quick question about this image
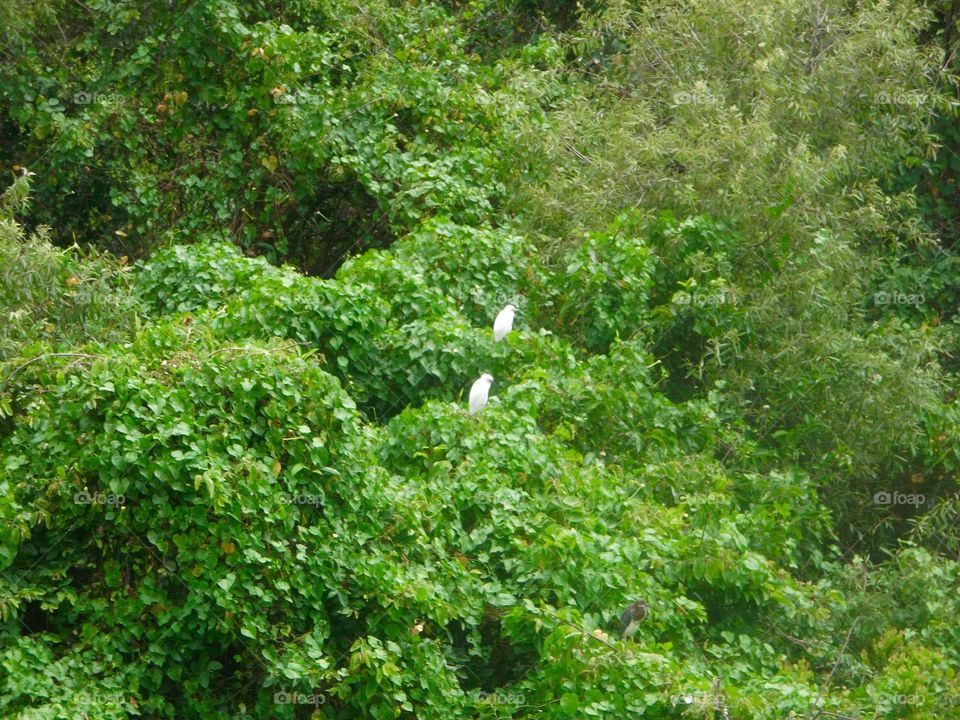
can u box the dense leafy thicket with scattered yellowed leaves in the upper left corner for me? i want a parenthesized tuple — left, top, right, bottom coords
(0, 0, 524, 268)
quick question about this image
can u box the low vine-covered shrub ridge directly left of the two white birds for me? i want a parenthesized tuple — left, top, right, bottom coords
(137, 229, 543, 422)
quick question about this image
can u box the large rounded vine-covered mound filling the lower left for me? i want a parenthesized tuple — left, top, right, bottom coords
(0, 324, 476, 716)
